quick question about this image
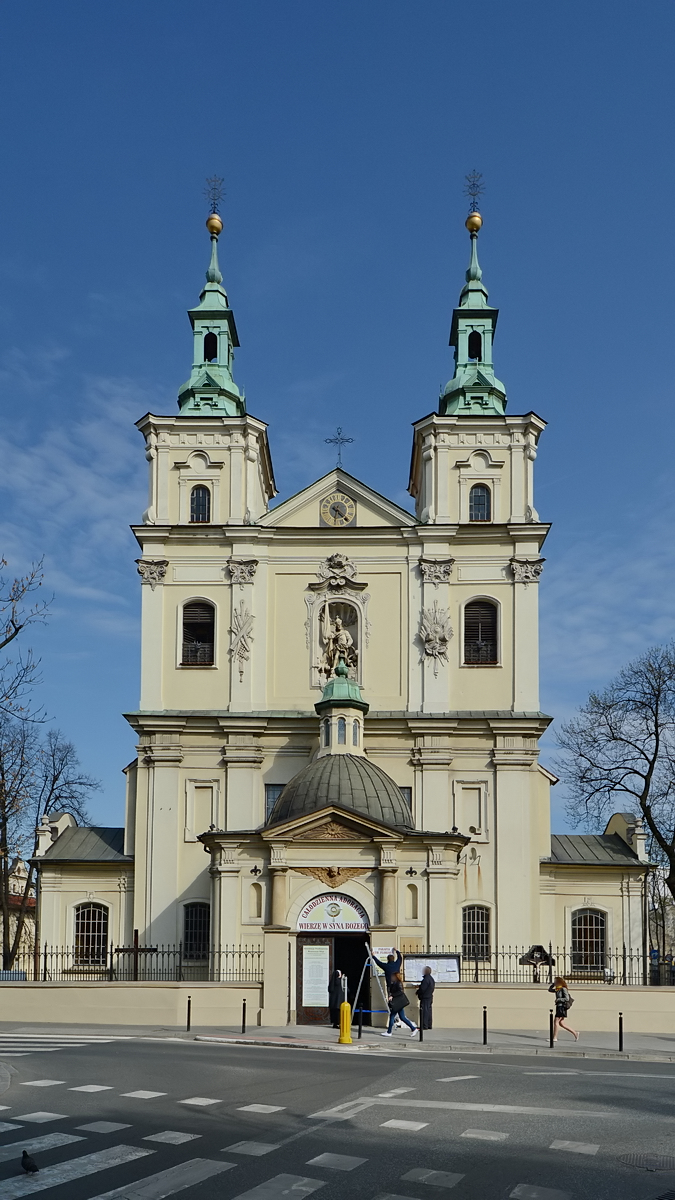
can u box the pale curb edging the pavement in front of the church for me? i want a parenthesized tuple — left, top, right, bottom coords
(193, 1034, 675, 1063)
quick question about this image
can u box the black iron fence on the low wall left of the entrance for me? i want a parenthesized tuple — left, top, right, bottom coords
(4, 943, 264, 983)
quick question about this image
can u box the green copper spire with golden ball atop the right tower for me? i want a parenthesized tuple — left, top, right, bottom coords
(438, 211, 507, 416)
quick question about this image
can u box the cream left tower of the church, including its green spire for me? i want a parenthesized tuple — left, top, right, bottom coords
(125, 212, 276, 944)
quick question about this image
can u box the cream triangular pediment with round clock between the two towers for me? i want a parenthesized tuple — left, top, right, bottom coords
(257, 467, 417, 533)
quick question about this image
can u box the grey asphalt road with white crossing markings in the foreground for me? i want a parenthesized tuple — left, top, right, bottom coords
(0, 1031, 675, 1200)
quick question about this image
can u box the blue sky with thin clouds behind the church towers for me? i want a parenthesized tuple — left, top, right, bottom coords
(0, 0, 675, 830)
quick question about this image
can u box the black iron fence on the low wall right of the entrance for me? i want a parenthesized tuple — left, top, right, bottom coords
(401, 942, 653, 986)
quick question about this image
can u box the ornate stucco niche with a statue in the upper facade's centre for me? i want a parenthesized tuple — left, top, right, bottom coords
(305, 553, 370, 686)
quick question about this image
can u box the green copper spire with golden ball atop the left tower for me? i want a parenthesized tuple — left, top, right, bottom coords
(178, 212, 246, 416)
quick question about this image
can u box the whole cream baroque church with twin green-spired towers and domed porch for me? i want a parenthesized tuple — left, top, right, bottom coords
(36, 204, 647, 1025)
